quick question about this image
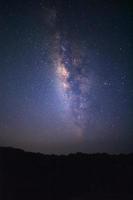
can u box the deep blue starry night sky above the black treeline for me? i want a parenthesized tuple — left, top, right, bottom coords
(0, 0, 133, 154)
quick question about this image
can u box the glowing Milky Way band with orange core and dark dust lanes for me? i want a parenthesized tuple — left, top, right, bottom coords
(54, 31, 91, 133)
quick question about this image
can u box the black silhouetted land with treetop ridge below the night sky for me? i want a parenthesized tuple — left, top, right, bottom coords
(0, 147, 133, 200)
